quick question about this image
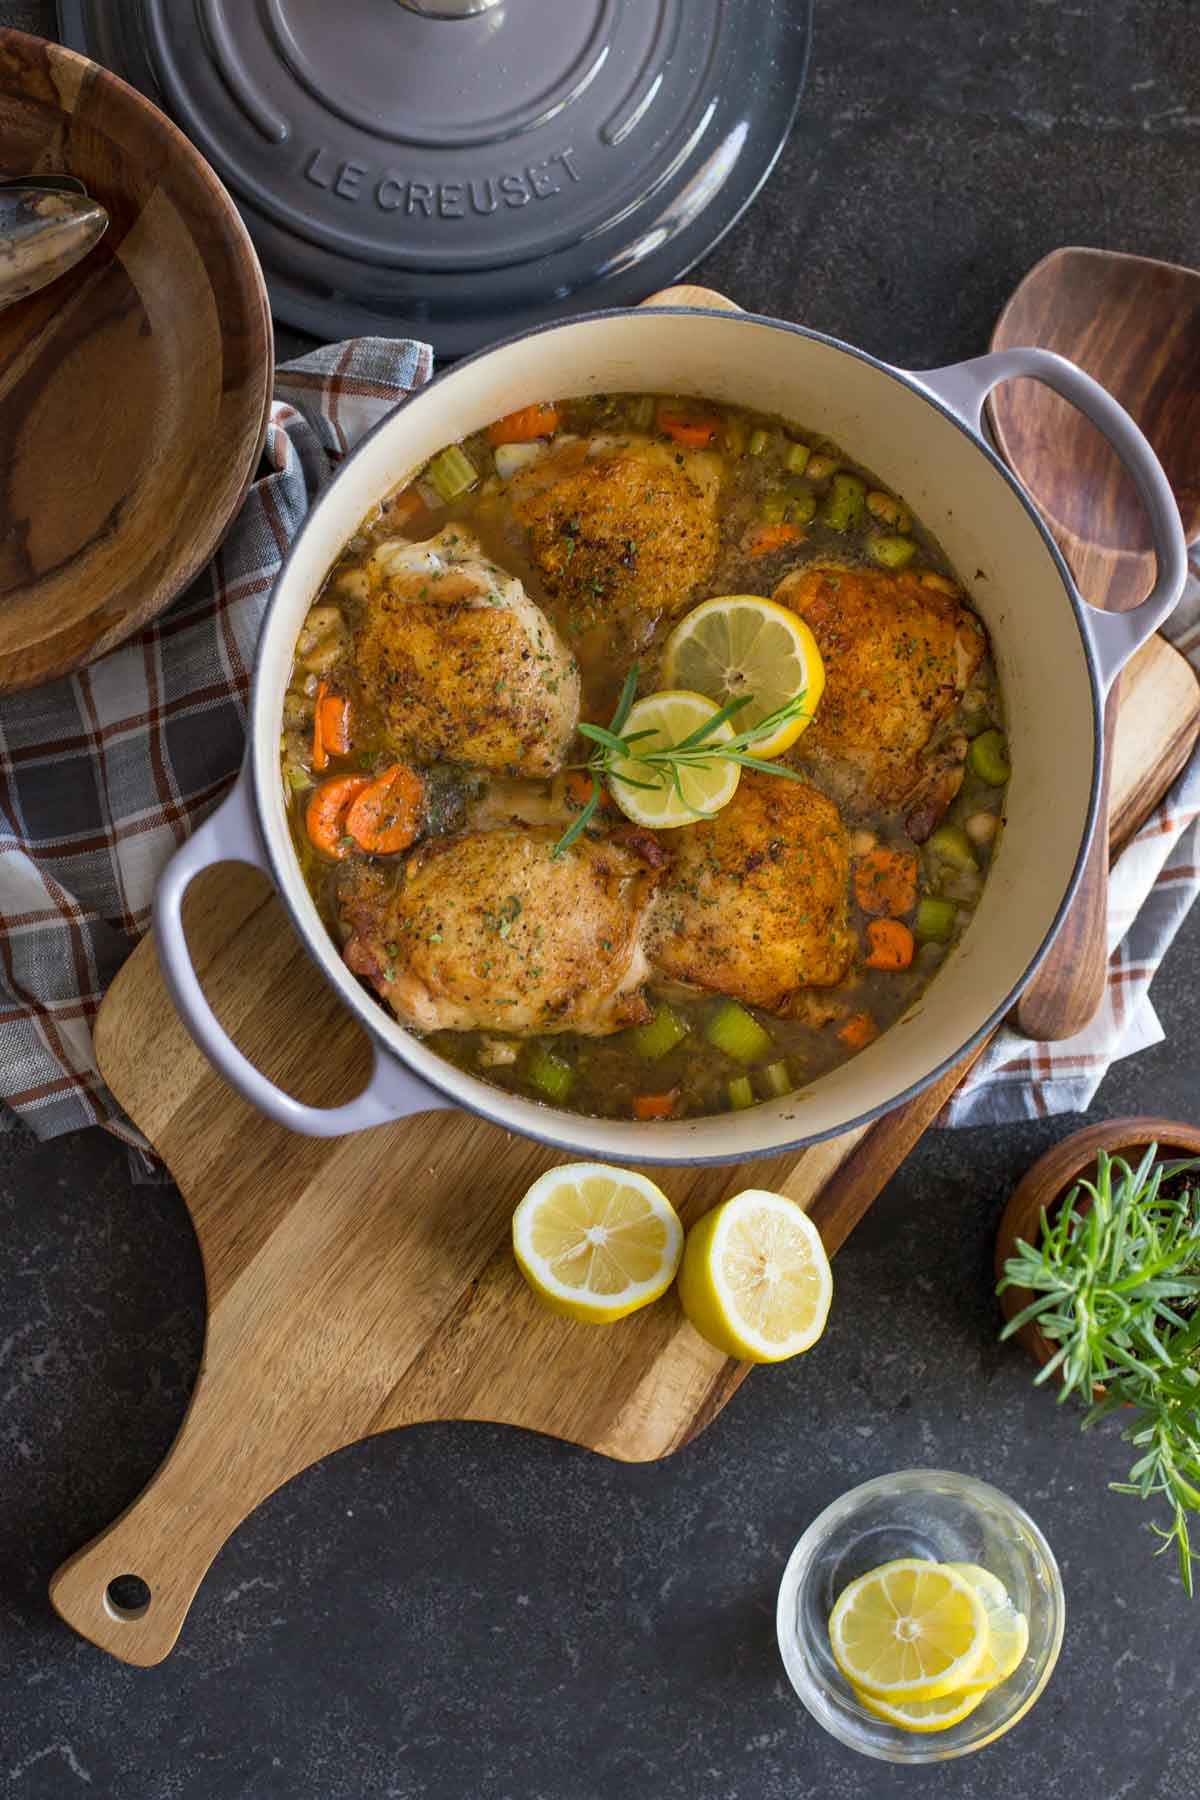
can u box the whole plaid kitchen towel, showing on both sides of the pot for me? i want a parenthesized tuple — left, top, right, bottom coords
(0, 338, 1200, 1145)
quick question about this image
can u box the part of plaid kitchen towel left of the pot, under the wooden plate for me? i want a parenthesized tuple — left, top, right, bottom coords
(0, 338, 432, 1143)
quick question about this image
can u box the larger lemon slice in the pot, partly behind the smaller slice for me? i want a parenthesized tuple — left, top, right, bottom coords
(662, 594, 826, 756)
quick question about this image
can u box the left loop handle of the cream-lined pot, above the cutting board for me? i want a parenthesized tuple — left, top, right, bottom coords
(155, 767, 453, 1138)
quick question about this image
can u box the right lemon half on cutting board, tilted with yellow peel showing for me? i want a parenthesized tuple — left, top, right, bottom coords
(678, 1188, 833, 1363)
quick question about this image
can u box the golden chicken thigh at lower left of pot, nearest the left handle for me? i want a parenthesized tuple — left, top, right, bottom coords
(340, 826, 658, 1037)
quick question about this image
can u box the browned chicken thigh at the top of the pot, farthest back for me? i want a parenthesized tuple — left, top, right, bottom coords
(509, 436, 720, 634)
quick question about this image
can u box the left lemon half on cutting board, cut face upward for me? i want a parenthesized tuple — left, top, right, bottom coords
(513, 1163, 684, 1325)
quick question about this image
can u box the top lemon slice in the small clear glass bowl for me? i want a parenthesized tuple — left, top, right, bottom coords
(829, 1557, 988, 1705)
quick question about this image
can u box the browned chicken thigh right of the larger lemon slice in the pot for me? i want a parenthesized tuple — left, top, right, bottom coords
(774, 563, 986, 835)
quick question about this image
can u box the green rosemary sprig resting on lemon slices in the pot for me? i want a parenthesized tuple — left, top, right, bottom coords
(552, 662, 806, 857)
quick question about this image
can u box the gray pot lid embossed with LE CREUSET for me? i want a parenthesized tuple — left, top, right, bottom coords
(59, 0, 811, 356)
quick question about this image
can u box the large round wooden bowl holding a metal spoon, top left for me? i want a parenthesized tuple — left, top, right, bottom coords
(0, 31, 272, 691)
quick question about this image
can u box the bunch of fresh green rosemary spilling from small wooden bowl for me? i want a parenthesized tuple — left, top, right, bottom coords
(999, 1145, 1200, 1595)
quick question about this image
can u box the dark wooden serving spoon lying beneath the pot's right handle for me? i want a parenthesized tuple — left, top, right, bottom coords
(988, 248, 1200, 1040)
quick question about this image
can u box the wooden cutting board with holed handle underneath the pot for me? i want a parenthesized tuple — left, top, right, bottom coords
(50, 639, 1200, 1665)
